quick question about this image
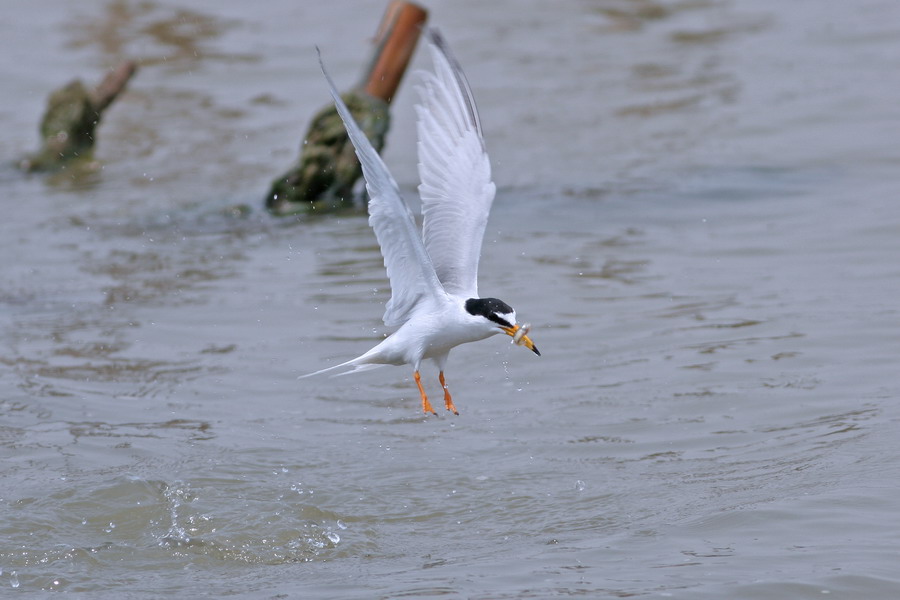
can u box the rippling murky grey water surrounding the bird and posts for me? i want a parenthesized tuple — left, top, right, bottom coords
(0, 0, 900, 599)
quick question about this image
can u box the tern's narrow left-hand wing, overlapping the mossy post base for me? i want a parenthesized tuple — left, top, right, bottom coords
(319, 50, 445, 327)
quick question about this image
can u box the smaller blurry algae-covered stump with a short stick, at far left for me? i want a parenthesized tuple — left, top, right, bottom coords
(19, 61, 137, 171)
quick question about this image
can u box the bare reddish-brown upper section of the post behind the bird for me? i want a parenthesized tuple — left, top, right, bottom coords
(361, 0, 428, 102)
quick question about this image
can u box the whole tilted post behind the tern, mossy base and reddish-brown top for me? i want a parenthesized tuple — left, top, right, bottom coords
(266, 0, 427, 214)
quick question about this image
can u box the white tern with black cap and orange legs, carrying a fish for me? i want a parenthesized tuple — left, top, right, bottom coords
(302, 29, 541, 415)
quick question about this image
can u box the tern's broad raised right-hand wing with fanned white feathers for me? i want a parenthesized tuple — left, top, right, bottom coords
(416, 29, 496, 298)
